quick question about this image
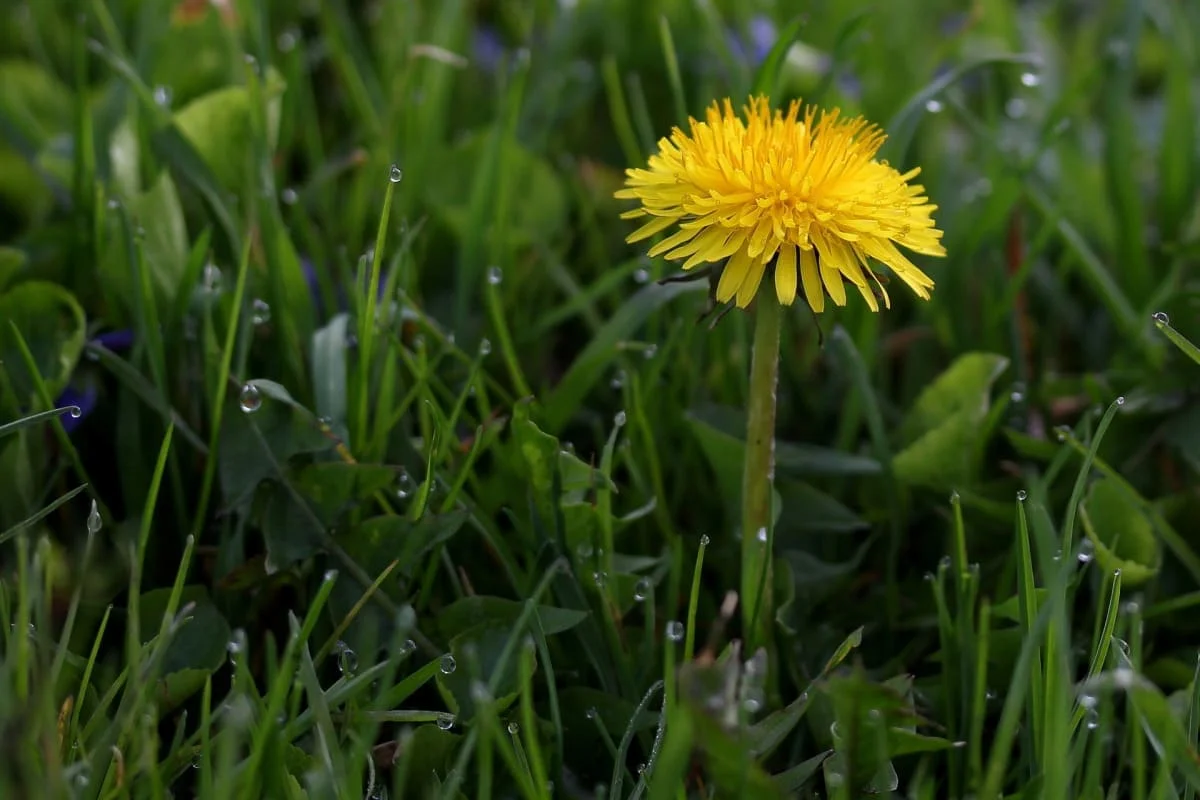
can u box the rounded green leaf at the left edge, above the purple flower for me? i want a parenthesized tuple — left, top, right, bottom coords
(0, 281, 86, 404)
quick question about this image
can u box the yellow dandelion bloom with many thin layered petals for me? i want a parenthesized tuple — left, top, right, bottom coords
(616, 97, 946, 312)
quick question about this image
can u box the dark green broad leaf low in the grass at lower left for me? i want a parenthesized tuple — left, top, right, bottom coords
(138, 585, 229, 717)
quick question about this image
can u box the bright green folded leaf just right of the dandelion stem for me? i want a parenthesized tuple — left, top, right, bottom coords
(893, 353, 1008, 489)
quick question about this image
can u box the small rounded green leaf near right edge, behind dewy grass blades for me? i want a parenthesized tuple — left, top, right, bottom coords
(1079, 477, 1163, 587)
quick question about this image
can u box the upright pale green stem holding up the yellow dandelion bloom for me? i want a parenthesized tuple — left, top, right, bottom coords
(742, 287, 782, 654)
